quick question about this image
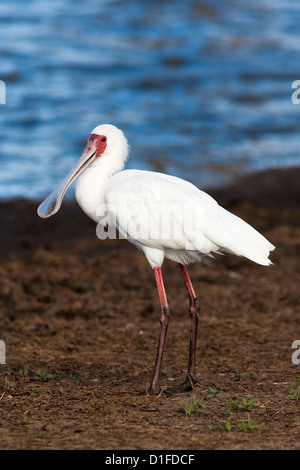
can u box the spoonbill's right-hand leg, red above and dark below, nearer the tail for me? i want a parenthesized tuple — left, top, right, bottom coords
(180, 264, 200, 385)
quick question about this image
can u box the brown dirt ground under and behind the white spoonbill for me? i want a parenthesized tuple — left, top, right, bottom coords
(0, 169, 300, 450)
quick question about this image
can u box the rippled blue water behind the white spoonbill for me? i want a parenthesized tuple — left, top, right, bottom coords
(0, 0, 300, 198)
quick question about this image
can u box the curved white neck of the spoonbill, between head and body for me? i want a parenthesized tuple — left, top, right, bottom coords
(75, 147, 128, 222)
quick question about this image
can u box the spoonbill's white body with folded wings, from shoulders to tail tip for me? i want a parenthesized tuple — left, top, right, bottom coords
(104, 170, 274, 265)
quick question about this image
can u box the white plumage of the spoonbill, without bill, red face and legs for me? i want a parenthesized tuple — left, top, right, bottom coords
(72, 125, 274, 268)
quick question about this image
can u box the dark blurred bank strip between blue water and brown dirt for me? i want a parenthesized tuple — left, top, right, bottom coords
(0, 167, 300, 258)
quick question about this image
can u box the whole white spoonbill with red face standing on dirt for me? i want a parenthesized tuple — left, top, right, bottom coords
(38, 124, 275, 394)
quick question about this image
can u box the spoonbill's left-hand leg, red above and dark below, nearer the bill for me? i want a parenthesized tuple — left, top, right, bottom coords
(148, 267, 170, 395)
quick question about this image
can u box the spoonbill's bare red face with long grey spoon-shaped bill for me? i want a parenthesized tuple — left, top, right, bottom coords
(38, 134, 107, 219)
